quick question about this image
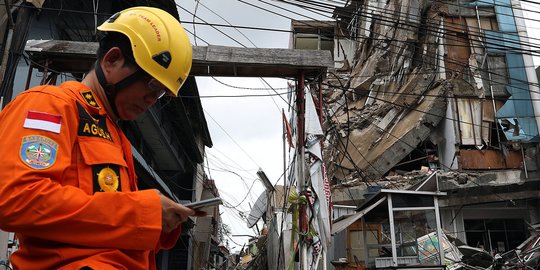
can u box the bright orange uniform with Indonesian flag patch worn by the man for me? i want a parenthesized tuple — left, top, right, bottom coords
(0, 82, 180, 270)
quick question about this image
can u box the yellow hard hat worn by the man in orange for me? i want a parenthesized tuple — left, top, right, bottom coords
(97, 7, 192, 96)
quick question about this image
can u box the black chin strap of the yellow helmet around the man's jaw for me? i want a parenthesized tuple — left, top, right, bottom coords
(94, 60, 146, 119)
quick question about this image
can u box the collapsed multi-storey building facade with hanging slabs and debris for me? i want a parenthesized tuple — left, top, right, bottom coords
(292, 0, 540, 265)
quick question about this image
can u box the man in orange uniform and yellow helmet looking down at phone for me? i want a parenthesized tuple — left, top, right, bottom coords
(0, 7, 201, 270)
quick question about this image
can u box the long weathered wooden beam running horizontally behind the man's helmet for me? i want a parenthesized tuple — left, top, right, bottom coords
(25, 40, 334, 78)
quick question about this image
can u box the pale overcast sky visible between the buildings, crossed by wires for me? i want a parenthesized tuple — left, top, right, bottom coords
(177, 0, 540, 251)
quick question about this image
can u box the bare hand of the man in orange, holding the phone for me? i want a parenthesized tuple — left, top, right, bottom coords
(156, 190, 198, 232)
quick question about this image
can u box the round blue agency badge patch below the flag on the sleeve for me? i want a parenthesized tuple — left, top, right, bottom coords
(19, 135, 58, 170)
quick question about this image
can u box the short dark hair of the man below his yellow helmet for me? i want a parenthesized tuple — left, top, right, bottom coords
(96, 32, 137, 66)
